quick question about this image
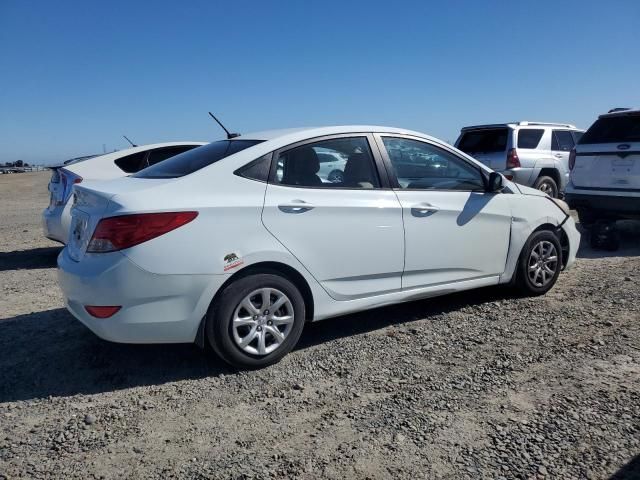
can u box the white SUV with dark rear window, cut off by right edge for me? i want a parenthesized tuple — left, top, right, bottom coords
(566, 109, 640, 226)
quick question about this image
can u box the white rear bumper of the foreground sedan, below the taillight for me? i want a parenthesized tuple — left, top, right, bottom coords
(58, 248, 228, 343)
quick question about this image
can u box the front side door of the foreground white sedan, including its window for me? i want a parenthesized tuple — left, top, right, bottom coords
(376, 135, 511, 289)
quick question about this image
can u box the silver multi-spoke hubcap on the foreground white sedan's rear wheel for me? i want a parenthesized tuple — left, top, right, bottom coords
(231, 288, 294, 356)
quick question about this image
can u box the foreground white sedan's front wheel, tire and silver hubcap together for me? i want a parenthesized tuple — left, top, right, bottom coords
(516, 230, 562, 296)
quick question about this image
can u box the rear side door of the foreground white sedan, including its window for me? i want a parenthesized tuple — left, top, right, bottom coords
(262, 134, 404, 300)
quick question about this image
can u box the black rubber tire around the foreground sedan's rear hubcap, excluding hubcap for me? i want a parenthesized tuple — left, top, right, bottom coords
(206, 273, 305, 369)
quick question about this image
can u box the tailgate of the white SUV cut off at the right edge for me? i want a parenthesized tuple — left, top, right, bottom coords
(571, 112, 640, 193)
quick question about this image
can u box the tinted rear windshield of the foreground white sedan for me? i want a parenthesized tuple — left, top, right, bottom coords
(133, 140, 262, 178)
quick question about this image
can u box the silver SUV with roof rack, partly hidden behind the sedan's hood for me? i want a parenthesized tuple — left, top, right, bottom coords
(456, 122, 583, 198)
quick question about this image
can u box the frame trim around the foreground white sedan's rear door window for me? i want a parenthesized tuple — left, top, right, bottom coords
(268, 132, 392, 192)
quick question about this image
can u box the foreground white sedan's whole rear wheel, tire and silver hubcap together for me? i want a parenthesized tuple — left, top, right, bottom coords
(205, 273, 305, 369)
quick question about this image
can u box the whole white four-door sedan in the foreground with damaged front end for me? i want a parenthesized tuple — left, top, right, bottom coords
(58, 126, 580, 368)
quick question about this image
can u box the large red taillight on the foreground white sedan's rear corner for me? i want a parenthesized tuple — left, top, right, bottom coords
(87, 212, 198, 253)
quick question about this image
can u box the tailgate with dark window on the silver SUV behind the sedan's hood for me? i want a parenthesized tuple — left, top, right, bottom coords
(456, 126, 511, 172)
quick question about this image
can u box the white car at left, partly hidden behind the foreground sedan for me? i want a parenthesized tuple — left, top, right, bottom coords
(42, 142, 206, 243)
